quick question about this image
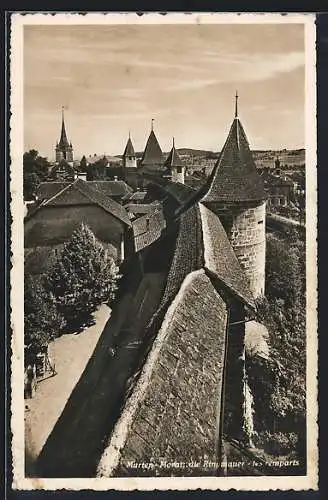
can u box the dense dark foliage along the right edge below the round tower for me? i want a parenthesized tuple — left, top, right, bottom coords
(247, 231, 306, 448)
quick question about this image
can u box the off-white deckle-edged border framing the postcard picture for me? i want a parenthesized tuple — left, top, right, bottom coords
(10, 12, 318, 491)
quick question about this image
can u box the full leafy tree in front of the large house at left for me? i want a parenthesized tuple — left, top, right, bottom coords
(47, 224, 119, 328)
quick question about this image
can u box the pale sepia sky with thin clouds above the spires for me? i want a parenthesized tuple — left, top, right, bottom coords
(24, 24, 305, 160)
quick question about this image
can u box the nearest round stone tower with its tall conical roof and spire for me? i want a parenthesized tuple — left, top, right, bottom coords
(202, 93, 266, 297)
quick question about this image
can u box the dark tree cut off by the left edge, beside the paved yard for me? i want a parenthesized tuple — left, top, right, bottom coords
(24, 275, 64, 352)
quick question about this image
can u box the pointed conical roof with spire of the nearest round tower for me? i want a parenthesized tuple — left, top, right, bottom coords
(202, 93, 266, 202)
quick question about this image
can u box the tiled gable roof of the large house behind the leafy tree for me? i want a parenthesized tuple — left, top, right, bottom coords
(39, 179, 131, 226)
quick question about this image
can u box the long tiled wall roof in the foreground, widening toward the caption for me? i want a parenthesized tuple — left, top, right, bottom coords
(108, 271, 227, 476)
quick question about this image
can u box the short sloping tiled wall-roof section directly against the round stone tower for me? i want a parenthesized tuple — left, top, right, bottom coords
(199, 203, 254, 307)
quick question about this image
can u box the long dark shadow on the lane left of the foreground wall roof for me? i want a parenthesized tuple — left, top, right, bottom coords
(33, 229, 174, 477)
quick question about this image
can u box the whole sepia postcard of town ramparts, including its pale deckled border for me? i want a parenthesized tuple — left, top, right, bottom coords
(10, 13, 317, 490)
